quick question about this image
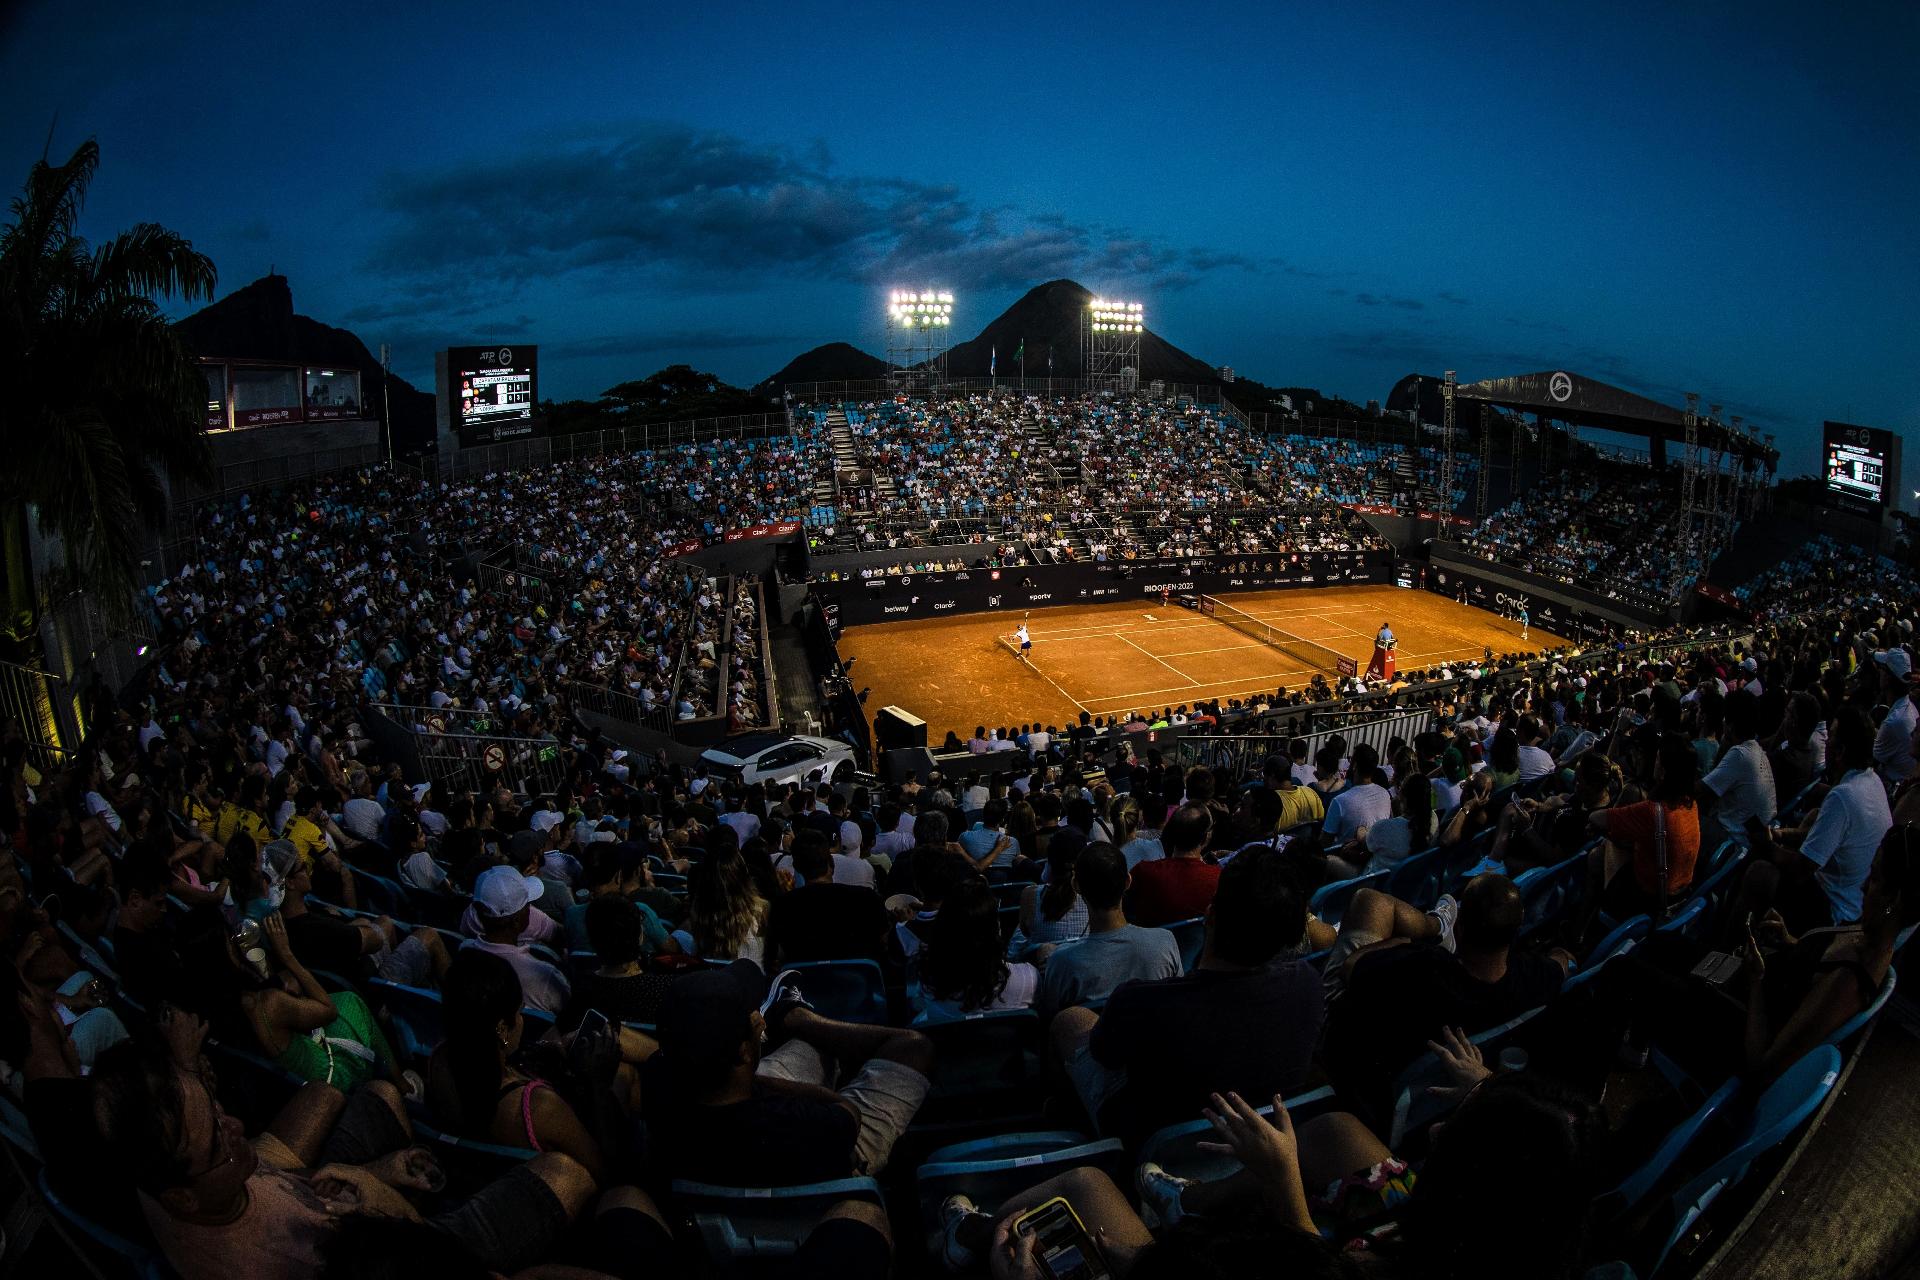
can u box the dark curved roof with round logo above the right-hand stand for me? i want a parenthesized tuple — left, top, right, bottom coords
(1386, 368, 1780, 462)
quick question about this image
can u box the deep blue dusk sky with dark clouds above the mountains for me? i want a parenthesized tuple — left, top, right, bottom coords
(0, 2, 1920, 482)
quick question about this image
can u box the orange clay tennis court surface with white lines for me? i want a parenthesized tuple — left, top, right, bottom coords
(839, 585, 1563, 745)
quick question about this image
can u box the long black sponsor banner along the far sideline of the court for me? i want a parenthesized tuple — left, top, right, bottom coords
(814, 551, 1394, 626)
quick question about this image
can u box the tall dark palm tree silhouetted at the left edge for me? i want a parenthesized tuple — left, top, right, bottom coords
(0, 140, 215, 631)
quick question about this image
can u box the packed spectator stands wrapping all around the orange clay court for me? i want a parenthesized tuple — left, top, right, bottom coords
(0, 383, 1920, 1280)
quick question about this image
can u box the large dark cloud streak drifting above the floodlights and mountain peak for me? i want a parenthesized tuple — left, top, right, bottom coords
(367, 123, 1265, 317)
